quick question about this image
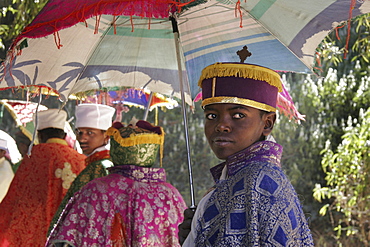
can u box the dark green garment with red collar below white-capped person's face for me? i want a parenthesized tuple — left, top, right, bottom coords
(48, 150, 113, 233)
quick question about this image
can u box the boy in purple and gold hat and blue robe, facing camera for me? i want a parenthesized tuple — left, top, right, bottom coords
(179, 63, 313, 247)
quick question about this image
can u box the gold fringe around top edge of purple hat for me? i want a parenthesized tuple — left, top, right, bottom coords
(198, 63, 283, 92)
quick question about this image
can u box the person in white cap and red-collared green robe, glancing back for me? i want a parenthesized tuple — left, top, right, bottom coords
(49, 104, 115, 233)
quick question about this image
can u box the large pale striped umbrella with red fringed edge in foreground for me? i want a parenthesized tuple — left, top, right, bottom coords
(0, 0, 370, 206)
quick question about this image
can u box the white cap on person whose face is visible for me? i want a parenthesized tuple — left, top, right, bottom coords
(75, 104, 116, 130)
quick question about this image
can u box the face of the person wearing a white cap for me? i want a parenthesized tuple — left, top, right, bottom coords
(76, 128, 109, 155)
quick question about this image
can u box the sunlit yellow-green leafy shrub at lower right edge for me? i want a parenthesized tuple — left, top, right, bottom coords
(314, 108, 370, 246)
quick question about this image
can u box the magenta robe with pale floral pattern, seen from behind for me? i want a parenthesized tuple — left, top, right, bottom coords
(47, 165, 186, 247)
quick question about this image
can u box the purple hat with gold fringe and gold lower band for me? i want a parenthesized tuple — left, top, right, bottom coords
(198, 63, 283, 112)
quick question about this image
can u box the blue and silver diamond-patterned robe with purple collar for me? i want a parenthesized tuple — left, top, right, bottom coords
(195, 141, 313, 247)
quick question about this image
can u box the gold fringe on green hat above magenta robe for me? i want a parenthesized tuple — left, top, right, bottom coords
(106, 127, 165, 167)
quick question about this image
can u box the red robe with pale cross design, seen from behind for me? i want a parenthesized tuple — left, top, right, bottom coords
(0, 138, 85, 247)
